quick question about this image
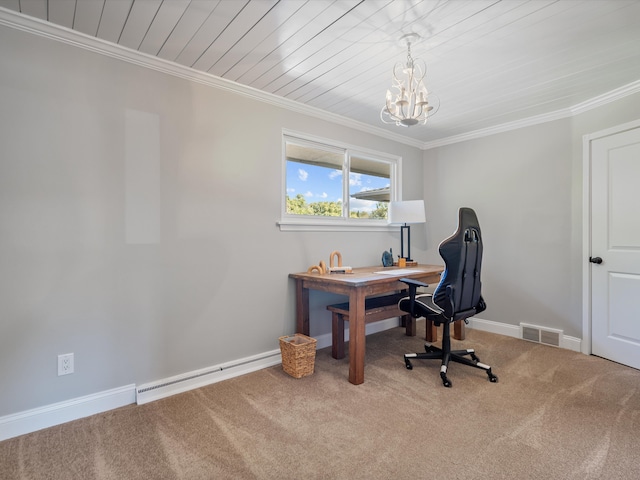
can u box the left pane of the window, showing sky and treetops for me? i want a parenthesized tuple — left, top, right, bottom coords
(286, 142, 344, 217)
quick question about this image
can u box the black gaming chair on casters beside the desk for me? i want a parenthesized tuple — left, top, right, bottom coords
(398, 208, 498, 387)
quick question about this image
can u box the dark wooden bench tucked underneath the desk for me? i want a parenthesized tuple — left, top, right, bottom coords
(327, 292, 465, 359)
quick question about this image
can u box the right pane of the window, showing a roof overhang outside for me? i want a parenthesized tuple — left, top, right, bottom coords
(349, 156, 391, 220)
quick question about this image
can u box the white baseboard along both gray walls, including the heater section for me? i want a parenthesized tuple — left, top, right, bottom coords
(0, 318, 581, 441)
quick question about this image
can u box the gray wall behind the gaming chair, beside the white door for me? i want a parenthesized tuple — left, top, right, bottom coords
(424, 94, 640, 338)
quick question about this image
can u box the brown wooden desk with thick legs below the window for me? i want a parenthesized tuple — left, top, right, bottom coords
(289, 265, 444, 385)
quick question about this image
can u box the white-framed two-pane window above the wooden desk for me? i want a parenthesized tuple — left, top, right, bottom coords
(280, 133, 400, 229)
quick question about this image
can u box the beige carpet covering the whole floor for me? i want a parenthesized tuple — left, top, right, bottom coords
(0, 323, 640, 480)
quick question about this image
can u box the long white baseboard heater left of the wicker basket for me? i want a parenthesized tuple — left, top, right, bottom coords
(136, 349, 282, 405)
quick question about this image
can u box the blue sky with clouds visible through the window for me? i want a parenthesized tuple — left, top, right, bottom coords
(287, 161, 389, 210)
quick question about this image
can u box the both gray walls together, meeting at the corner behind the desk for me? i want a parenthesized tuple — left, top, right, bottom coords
(0, 19, 640, 416)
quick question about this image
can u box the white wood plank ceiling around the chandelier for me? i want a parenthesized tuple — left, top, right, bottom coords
(0, 0, 640, 144)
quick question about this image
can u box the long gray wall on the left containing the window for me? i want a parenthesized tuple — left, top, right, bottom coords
(0, 26, 424, 416)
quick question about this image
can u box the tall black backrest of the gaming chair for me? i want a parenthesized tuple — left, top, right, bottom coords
(433, 207, 486, 318)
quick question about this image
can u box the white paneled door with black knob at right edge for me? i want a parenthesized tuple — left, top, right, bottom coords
(590, 128, 640, 368)
